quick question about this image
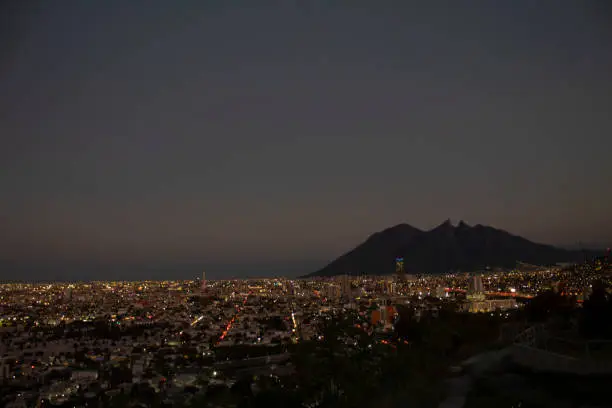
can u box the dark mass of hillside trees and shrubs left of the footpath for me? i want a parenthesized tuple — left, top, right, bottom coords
(208, 313, 502, 407)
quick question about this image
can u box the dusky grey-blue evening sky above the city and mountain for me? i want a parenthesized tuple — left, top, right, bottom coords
(0, 0, 612, 279)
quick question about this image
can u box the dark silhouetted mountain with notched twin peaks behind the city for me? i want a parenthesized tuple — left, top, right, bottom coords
(308, 220, 592, 276)
